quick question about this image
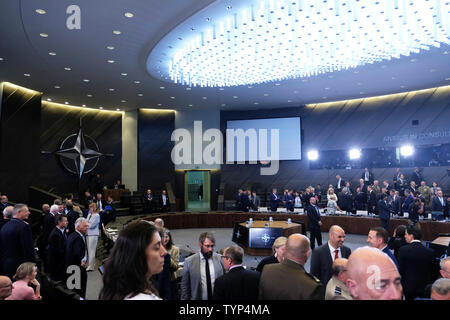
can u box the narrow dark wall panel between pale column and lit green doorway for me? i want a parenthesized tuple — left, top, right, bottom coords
(138, 109, 175, 192)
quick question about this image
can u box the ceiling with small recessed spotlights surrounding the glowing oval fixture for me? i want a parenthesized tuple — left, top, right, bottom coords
(0, 0, 450, 110)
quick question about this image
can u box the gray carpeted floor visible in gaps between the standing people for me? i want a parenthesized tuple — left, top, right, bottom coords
(86, 220, 367, 300)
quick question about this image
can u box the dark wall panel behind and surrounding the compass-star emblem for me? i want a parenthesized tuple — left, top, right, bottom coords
(37, 102, 122, 195)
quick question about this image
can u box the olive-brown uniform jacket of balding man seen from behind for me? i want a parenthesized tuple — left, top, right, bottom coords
(259, 259, 324, 300)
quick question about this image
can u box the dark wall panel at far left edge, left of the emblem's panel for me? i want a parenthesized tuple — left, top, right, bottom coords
(0, 84, 42, 203)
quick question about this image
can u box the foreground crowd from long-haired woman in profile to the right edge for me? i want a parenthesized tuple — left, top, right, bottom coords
(92, 215, 450, 300)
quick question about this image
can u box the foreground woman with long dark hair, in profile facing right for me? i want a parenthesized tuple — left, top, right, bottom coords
(99, 221, 167, 300)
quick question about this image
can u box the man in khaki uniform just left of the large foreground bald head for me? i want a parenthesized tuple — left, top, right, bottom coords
(325, 258, 353, 300)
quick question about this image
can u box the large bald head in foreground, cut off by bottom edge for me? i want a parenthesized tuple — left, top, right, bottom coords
(346, 247, 403, 300)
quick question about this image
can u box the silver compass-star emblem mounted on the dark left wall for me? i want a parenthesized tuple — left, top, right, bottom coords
(42, 119, 114, 179)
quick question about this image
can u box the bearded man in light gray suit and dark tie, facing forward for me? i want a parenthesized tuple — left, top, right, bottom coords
(181, 232, 224, 300)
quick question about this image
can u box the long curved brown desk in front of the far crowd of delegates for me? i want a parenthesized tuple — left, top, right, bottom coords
(143, 212, 450, 241)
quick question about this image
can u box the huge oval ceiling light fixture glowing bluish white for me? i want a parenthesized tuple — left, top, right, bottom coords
(147, 0, 450, 87)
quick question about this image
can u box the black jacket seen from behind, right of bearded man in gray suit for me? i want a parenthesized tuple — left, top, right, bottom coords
(213, 267, 260, 300)
